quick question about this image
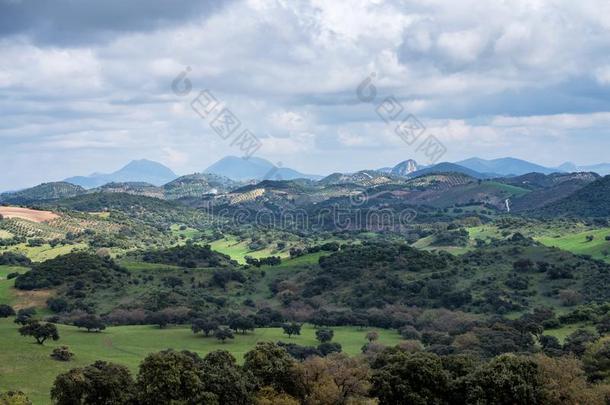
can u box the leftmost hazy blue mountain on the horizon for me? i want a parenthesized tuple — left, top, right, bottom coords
(64, 159, 178, 189)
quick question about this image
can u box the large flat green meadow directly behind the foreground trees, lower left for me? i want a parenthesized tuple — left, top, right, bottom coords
(0, 318, 400, 405)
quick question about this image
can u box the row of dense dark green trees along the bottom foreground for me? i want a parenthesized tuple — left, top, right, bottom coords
(0, 342, 592, 405)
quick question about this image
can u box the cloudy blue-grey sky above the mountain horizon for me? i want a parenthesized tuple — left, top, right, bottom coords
(0, 0, 610, 190)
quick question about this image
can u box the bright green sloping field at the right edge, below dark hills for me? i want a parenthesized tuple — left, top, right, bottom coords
(536, 228, 610, 263)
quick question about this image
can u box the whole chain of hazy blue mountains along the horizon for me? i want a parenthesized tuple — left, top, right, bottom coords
(5, 156, 610, 194)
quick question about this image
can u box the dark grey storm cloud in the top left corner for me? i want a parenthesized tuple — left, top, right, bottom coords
(0, 0, 231, 45)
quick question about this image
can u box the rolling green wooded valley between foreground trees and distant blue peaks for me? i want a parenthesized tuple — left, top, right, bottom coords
(0, 159, 610, 404)
